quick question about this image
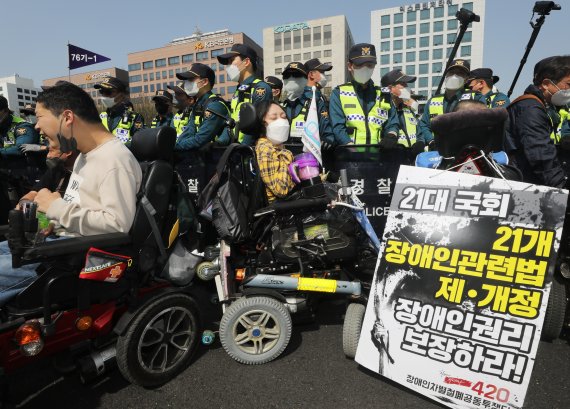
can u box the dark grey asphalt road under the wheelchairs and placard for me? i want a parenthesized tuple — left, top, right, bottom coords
(4, 296, 570, 409)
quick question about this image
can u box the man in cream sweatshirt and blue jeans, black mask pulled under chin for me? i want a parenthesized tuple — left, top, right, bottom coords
(0, 83, 142, 305)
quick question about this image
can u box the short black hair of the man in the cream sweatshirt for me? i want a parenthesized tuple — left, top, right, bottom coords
(36, 82, 101, 123)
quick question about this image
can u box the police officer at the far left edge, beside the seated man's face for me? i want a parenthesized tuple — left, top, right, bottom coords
(0, 95, 40, 161)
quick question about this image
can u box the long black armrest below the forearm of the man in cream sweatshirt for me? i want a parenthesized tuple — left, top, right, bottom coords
(24, 233, 131, 260)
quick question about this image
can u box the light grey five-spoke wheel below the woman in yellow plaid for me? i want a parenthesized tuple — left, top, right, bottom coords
(220, 297, 292, 365)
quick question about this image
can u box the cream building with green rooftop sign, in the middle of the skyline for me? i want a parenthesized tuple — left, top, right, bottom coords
(263, 16, 354, 93)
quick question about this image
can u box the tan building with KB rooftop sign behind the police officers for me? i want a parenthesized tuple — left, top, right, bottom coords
(128, 30, 263, 99)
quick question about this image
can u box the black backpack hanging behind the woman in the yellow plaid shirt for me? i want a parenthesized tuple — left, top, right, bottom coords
(198, 143, 266, 244)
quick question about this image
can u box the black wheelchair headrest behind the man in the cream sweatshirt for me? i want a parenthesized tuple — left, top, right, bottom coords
(131, 126, 176, 162)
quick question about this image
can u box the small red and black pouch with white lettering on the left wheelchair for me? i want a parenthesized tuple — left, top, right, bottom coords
(79, 247, 132, 283)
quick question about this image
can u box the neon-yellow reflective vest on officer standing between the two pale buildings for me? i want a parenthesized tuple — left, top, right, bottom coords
(339, 84, 391, 145)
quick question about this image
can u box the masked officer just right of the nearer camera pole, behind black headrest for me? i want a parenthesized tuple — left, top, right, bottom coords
(417, 59, 472, 145)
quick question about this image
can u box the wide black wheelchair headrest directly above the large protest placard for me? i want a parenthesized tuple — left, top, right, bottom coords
(431, 108, 508, 157)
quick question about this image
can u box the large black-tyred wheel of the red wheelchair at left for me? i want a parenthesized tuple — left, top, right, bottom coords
(117, 293, 199, 387)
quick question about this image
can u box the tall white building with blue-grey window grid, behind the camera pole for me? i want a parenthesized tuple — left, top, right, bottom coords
(371, 0, 485, 97)
